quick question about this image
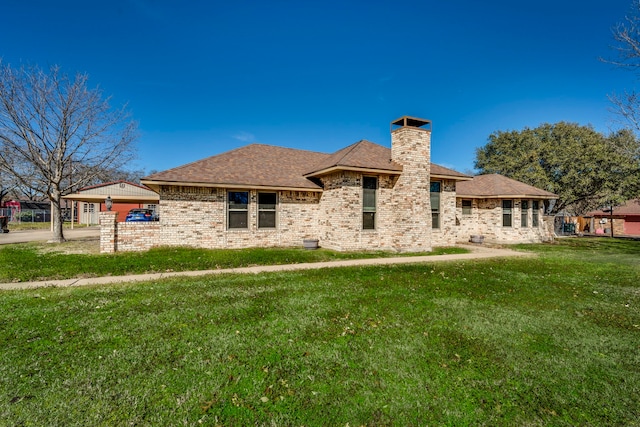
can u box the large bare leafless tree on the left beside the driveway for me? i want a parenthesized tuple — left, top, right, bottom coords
(0, 62, 137, 242)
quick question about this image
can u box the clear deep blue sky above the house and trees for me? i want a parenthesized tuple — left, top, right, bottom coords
(0, 0, 636, 176)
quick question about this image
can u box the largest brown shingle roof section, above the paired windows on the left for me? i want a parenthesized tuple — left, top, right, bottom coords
(142, 144, 328, 191)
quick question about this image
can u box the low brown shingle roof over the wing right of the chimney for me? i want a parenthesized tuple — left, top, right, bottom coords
(456, 174, 558, 199)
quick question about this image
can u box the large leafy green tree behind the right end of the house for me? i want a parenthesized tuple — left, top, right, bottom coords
(475, 122, 640, 214)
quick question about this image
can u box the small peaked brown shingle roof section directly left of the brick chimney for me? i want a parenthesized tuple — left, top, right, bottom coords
(305, 140, 402, 177)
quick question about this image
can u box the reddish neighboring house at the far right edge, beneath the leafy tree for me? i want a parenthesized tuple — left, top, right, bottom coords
(585, 199, 640, 236)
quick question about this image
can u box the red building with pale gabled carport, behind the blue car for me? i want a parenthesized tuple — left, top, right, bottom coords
(62, 181, 159, 224)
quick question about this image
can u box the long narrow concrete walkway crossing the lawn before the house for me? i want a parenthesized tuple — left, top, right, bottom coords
(0, 245, 535, 291)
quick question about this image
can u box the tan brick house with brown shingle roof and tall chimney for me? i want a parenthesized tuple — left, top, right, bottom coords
(102, 117, 555, 252)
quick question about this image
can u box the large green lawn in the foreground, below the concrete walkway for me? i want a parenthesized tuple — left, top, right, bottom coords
(0, 239, 640, 426)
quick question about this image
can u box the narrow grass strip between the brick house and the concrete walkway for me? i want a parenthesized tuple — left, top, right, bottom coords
(0, 241, 468, 283)
